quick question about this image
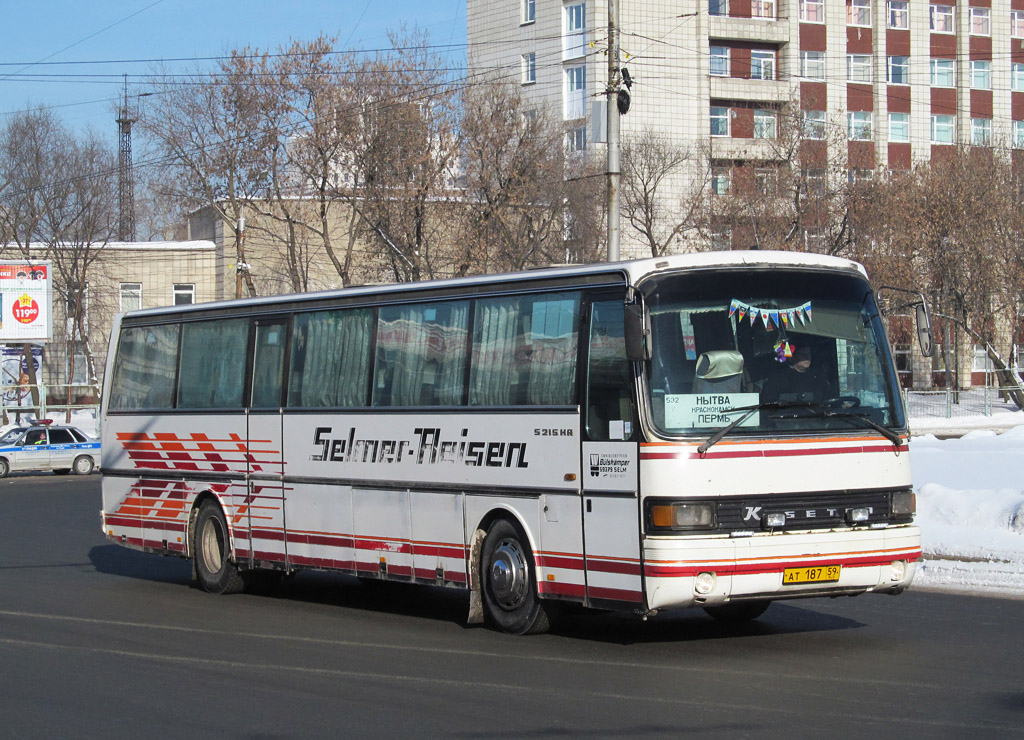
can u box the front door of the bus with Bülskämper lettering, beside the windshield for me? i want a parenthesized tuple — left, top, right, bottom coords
(582, 298, 643, 609)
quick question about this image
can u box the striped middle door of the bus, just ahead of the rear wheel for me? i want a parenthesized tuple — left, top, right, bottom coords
(247, 318, 288, 565)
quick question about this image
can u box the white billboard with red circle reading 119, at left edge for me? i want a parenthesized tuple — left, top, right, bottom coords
(0, 261, 53, 344)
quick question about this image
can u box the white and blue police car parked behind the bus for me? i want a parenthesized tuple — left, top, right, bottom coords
(0, 424, 99, 478)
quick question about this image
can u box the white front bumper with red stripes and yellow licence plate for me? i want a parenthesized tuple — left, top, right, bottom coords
(643, 525, 921, 610)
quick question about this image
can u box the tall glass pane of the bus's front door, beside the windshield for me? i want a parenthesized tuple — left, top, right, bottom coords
(587, 300, 637, 441)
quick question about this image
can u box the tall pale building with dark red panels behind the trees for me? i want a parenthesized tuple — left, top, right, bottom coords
(467, 0, 1024, 256)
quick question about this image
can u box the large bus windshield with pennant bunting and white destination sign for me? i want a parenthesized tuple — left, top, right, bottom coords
(641, 267, 904, 437)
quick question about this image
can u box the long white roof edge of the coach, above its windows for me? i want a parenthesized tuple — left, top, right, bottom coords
(125, 250, 867, 318)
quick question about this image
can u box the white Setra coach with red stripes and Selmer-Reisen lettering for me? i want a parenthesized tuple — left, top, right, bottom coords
(102, 252, 921, 634)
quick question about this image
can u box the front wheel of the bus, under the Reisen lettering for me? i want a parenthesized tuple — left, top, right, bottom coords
(480, 519, 552, 635)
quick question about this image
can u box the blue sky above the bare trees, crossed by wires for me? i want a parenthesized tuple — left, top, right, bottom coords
(0, 0, 466, 139)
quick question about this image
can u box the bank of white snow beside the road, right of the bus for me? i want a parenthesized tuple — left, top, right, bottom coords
(910, 426, 1024, 597)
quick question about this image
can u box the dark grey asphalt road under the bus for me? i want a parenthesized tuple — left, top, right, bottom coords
(0, 475, 1024, 740)
